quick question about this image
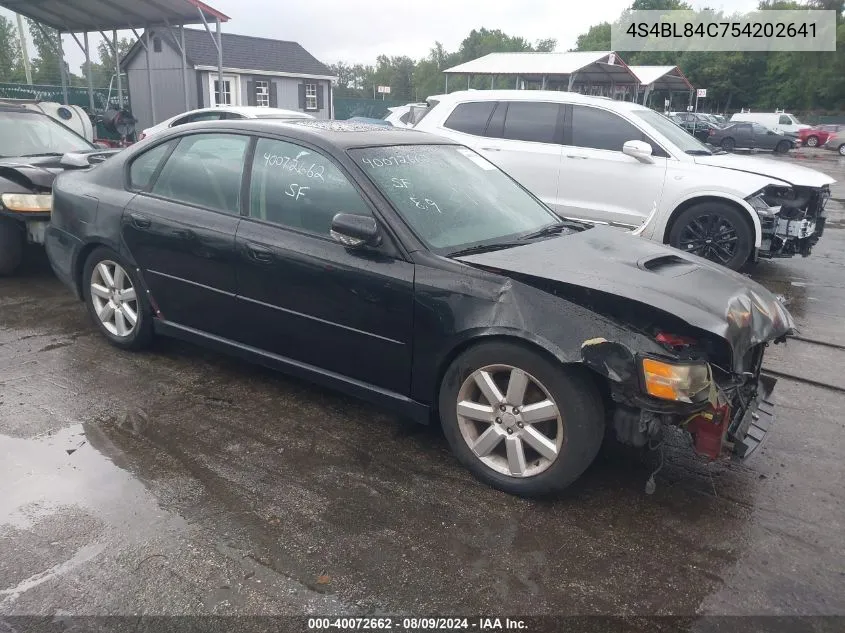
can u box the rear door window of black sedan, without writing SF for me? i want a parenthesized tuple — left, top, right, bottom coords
(153, 134, 249, 213)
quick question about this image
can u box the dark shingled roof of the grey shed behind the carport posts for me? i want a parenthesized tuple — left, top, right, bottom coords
(121, 29, 334, 77)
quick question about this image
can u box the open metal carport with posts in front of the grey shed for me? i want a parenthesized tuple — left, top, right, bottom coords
(0, 0, 229, 124)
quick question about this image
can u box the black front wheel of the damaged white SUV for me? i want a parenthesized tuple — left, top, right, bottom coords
(669, 202, 754, 270)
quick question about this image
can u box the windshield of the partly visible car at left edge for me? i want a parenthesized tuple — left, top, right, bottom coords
(0, 111, 95, 157)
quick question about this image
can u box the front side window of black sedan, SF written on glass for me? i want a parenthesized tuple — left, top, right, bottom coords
(249, 138, 372, 236)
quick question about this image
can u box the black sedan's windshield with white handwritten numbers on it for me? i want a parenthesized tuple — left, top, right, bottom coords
(350, 145, 560, 254)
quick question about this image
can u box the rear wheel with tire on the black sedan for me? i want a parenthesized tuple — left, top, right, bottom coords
(82, 247, 153, 350)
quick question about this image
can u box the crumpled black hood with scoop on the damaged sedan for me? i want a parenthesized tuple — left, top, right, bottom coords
(458, 226, 795, 369)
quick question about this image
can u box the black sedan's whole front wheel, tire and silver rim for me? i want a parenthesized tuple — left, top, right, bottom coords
(439, 341, 604, 497)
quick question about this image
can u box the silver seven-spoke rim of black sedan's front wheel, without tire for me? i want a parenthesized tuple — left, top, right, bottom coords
(457, 365, 564, 478)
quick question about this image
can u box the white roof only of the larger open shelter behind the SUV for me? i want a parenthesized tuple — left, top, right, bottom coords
(443, 51, 637, 84)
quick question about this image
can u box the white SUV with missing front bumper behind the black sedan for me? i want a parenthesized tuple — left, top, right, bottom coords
(415, 90, 835, 270)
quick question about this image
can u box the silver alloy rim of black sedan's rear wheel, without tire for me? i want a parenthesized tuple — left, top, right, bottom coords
(91, 260, 138, 337)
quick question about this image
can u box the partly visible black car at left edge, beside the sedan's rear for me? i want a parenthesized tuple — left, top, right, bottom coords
(0, 105, 113, 275)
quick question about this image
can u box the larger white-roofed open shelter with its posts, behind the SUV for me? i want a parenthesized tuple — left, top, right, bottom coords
(443, 51, 639, 95)
